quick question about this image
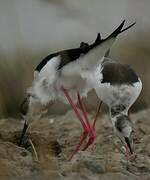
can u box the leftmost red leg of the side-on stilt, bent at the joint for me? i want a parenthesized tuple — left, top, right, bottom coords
(62, 87, 90, 159)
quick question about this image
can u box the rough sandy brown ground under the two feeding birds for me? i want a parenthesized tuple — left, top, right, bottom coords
(0, 109, 150, 180)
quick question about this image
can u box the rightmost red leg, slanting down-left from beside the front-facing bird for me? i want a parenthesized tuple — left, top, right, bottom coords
(82, 101, 102, 151)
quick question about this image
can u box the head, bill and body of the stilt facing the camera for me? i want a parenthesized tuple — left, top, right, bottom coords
(91, 50, 142, 156)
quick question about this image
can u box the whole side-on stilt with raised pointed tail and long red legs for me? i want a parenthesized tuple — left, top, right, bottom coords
(19, 20, 134, 158)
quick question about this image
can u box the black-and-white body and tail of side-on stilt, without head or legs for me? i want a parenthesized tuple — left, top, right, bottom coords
(24, 21, 134, 107)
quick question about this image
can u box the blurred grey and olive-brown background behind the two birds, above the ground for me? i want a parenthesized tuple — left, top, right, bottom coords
(0, 0, 150, 117)
